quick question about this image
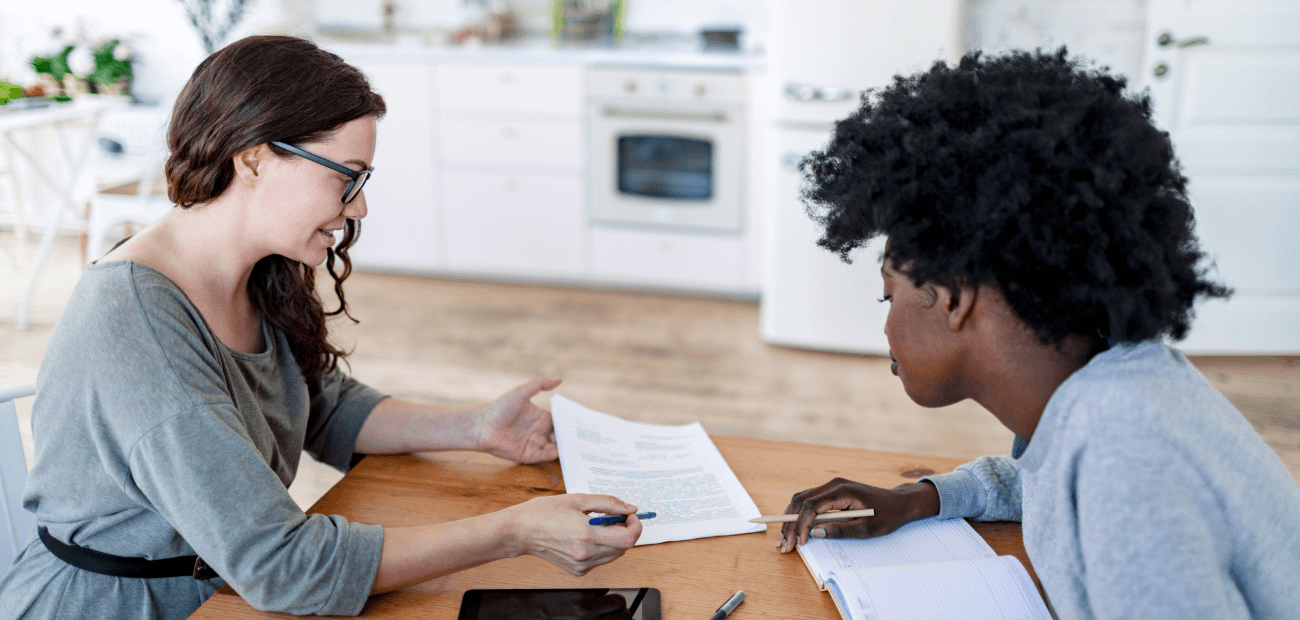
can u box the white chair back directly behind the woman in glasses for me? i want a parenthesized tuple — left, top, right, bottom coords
(0, 385, 36, 575)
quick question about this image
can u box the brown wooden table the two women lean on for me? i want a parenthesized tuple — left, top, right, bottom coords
(191, 437, 1041, 620)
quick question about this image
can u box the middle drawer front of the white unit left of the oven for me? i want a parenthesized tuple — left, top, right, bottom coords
(438, 117, 582, 170)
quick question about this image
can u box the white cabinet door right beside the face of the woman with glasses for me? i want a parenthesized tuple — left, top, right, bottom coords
(351, 61, 439, 270)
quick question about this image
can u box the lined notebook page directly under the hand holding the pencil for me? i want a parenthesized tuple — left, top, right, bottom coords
(796, 519, 997, 589)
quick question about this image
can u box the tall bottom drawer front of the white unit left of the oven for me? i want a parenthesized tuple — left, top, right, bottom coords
(442, 172, 586, 278)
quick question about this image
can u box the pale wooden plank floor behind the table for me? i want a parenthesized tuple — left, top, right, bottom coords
(0, 231, 1300, 506)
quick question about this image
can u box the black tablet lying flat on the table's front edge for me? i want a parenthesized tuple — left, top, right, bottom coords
(458, 588, 660, 620)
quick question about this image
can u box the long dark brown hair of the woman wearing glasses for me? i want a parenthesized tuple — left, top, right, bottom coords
(166, 36, 386, 382)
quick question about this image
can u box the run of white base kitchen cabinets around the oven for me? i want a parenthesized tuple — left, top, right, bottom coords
(334, 45, 758, 295)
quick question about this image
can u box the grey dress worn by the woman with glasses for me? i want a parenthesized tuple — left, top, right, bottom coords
(0, 261, 384, 620)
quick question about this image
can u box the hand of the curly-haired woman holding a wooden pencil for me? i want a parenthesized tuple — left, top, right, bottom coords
(776, 478, 939, 554)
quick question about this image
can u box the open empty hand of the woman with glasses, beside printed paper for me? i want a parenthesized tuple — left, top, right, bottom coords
(473, 377, 560, 463)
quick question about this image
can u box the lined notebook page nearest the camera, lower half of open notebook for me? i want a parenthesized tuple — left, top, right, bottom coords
(826, 555, 1052, 620)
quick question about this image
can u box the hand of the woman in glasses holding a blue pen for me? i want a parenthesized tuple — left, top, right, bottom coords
(502, 494, 641, 577)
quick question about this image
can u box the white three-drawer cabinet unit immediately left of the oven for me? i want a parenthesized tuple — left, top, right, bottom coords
(436, 62, 586, 278)
